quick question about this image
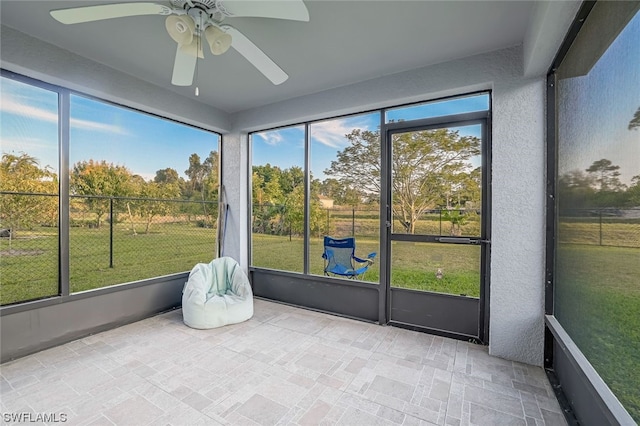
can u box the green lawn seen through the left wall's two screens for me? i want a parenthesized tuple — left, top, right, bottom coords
(0, 223, 215, 305)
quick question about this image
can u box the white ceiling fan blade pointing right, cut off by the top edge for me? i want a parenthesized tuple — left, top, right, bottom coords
(222, 0, 309, 22)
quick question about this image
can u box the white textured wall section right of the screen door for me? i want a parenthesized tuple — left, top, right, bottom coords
(489, 75, 545, 365)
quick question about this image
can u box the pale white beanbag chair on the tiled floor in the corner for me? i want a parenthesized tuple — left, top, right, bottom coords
(182, 257, 253, 329)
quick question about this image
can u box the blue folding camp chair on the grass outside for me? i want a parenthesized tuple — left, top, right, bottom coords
(322, 236, 376, 279)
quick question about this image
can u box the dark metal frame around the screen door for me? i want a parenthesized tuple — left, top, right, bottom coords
(379, 110, 491, 344)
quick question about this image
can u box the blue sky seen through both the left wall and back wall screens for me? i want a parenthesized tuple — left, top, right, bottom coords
(0, 73, 489, 183)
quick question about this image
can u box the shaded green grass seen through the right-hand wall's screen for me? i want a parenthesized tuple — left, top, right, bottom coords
(555, 244, 640, 423)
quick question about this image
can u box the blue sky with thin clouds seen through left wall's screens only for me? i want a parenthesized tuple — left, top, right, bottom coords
(0, 78, 219, 179)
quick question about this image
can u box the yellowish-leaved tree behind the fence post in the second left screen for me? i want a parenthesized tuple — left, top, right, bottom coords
(70, 159, 134, 228)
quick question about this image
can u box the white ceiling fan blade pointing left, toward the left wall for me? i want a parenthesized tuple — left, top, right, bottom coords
(49, 3, 172, 24)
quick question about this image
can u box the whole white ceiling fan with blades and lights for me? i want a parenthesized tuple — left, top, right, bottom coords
(50, 0, 309, 87)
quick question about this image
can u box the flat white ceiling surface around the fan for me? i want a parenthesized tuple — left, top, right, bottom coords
(0, 0, 535, 113)
